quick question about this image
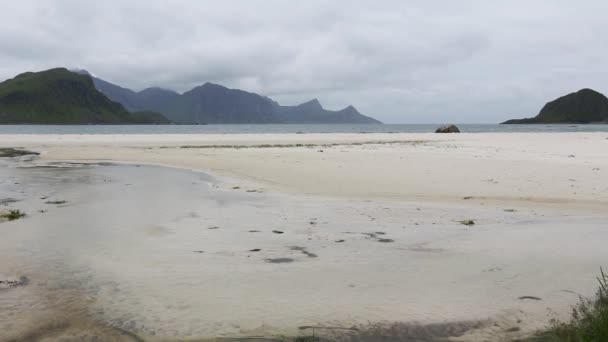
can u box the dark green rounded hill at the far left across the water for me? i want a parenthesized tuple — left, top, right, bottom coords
(0, 68, 170, 124)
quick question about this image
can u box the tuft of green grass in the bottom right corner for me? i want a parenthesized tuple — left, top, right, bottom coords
(530, 270, 608, 342)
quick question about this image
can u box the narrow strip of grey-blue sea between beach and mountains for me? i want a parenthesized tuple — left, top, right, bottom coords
(0, 124, 608, 134)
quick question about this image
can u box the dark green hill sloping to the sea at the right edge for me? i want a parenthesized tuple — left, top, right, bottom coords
(503, 89, 608, 124)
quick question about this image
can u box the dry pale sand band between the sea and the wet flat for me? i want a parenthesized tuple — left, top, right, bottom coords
(0, 133, 608, 208)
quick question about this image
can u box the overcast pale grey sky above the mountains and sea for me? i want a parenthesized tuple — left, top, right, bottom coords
(0, 0, 608, 123)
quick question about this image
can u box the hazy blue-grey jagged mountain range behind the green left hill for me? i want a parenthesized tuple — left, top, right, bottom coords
(78, 70, 381, 124)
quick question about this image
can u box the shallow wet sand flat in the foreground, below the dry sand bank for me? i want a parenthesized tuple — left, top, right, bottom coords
(0, 162, 608, 341)
